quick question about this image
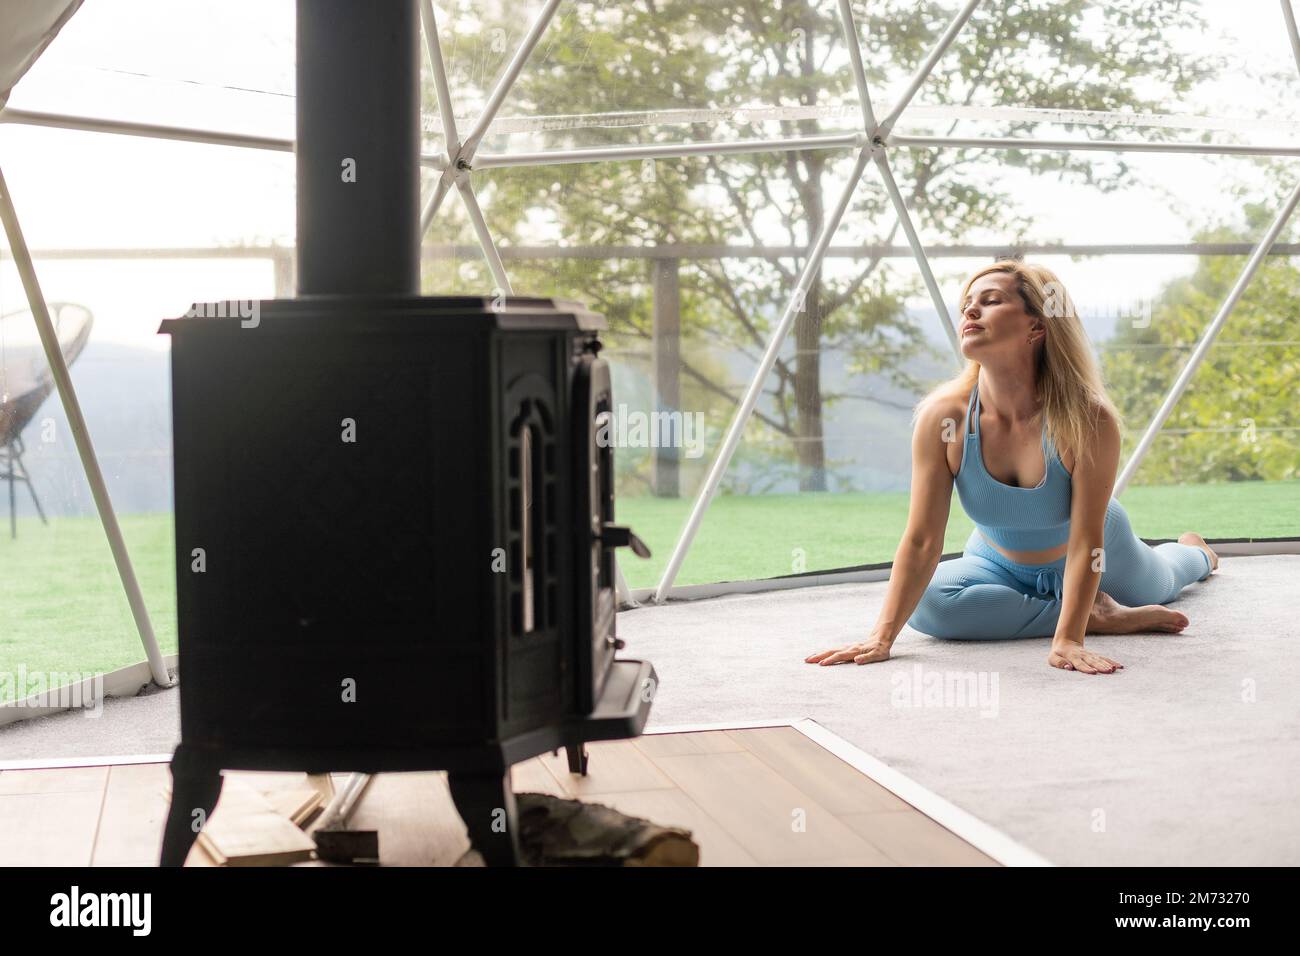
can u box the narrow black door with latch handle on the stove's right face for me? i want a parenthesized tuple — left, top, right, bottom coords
(573, 343, 616, 714)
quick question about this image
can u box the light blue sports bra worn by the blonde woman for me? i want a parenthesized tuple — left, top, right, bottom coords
(956, 381, 1071, 551)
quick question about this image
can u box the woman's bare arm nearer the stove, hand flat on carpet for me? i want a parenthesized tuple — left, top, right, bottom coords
(803, 402, 962, 663)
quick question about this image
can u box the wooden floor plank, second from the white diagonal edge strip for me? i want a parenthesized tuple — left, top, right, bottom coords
(655, 752, 891, 865)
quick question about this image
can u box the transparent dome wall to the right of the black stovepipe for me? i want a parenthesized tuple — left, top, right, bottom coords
(416, 3, 1300, 587)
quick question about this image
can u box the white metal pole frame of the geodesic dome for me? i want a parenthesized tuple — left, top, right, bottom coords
(0, 0, 1300, 684)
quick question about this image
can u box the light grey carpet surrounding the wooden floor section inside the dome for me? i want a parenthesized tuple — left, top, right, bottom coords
(0, 555, 1300, 866)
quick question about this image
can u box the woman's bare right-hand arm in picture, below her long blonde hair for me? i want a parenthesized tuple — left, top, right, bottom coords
(1048, 412, 1119, 674)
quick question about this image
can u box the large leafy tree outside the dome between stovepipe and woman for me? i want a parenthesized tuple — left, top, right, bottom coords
(429, 0, 1218, 490)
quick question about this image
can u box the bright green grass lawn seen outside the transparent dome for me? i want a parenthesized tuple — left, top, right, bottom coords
(0, 480, 1300, 701)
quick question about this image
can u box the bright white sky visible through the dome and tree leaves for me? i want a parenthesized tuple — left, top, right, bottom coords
(0, 0, 1300, 349)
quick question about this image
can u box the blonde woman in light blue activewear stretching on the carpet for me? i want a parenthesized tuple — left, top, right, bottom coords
(805, 260, 1218, 674)
